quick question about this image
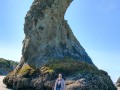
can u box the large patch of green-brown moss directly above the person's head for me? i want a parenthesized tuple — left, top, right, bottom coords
(45, 57, 99, 76)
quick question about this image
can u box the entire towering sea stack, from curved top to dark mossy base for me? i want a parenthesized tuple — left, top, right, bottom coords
(3, 0, 116, 90)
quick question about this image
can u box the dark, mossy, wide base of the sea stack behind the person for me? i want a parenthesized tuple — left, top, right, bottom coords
(3, 58, 117, 90)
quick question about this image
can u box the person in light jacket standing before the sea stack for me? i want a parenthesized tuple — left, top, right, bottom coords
(54, 74, 65, 90)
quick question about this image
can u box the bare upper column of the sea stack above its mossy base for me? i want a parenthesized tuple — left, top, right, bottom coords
(22, 0, 93, 68)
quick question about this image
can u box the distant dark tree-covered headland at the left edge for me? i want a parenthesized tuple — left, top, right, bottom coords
(0, 58, 18, 75)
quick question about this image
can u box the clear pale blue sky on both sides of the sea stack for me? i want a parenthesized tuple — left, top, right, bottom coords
(0, 0, 120, 82)
